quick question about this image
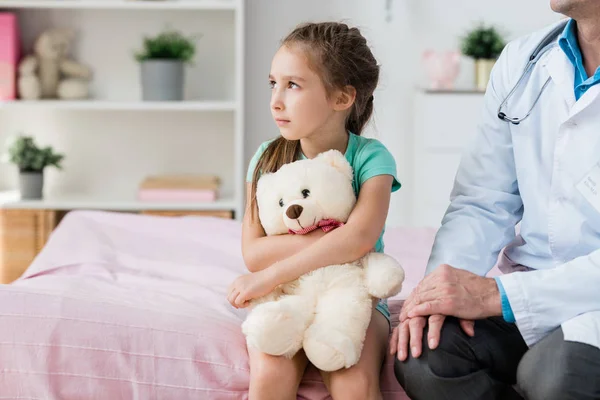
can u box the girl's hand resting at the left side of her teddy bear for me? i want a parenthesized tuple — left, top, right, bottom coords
(227, 268, 278, 308)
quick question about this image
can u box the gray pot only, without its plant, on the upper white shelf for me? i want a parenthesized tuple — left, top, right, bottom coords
(141, 60, 185, 101)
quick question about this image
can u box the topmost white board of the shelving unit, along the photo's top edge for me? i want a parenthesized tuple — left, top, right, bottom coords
(0, 0, 237, 10)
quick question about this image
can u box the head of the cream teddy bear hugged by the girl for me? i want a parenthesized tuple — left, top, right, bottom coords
(256, 150, 356, 235)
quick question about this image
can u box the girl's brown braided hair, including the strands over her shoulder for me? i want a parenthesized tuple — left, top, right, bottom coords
(251, 22, 379, 216)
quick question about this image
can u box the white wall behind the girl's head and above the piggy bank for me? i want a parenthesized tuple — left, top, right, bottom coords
(246, 0, 560, 226)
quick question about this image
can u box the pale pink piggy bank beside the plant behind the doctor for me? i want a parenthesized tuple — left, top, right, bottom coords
(422, 50, 460, 89)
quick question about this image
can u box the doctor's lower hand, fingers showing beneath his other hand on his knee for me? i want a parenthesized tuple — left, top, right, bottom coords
(390, 314, 475, 361)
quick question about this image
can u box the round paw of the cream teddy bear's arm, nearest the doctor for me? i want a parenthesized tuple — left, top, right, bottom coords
(362, 253, 404, 299)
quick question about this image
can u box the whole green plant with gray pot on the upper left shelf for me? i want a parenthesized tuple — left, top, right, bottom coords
(135, 30, 196, 101)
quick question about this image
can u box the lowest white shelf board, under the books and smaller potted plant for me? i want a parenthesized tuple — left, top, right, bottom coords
(0, 191, 236, 211)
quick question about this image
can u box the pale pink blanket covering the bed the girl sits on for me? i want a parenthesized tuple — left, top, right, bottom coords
(0, 211, 433, 400)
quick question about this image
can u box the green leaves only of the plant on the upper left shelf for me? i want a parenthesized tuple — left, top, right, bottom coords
(135, 30, 196, 63)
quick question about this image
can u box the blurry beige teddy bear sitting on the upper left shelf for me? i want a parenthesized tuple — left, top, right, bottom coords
(18, 28, 92, 100)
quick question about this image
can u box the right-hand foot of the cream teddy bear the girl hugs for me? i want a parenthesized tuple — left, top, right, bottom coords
(303, 325, 360, 371)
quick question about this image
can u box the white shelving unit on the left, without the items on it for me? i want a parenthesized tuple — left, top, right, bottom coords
(0, 0, 245, 219)
